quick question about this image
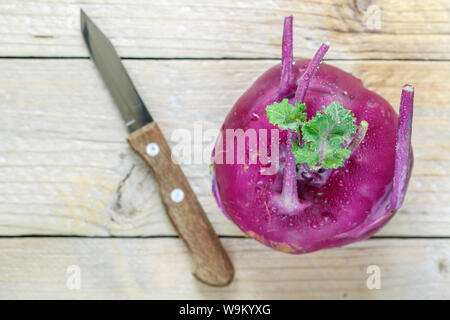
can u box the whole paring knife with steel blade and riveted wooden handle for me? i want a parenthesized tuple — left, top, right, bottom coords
(80, 10, 234, 285)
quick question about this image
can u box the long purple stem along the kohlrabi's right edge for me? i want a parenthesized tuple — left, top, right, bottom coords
(389, 84, 414, 210)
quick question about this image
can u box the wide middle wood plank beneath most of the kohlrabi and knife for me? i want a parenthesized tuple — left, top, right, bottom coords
(0, 59, 450, 236)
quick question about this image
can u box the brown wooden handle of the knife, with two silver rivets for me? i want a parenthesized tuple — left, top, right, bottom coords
(127, 122, 234, 286)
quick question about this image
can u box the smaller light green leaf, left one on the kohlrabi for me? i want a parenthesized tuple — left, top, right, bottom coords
(266, 99, 306, 132)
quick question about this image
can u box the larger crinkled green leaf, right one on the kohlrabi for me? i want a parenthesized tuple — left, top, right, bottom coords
(292, 101, 357, 169)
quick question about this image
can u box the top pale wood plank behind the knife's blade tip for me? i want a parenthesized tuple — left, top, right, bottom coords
(0, 0, 450, 59)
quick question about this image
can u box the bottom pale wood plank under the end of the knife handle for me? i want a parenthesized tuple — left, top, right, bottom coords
(0, 238, 450, 299)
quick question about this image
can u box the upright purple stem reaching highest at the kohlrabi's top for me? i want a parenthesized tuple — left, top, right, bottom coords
(278, 16, 295, 99)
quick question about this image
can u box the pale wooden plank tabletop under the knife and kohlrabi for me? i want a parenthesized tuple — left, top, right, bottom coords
(0, 0, 450, 299)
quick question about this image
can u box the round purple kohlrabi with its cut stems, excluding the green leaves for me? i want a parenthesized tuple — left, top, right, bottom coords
(213, 16, 414, 253)
